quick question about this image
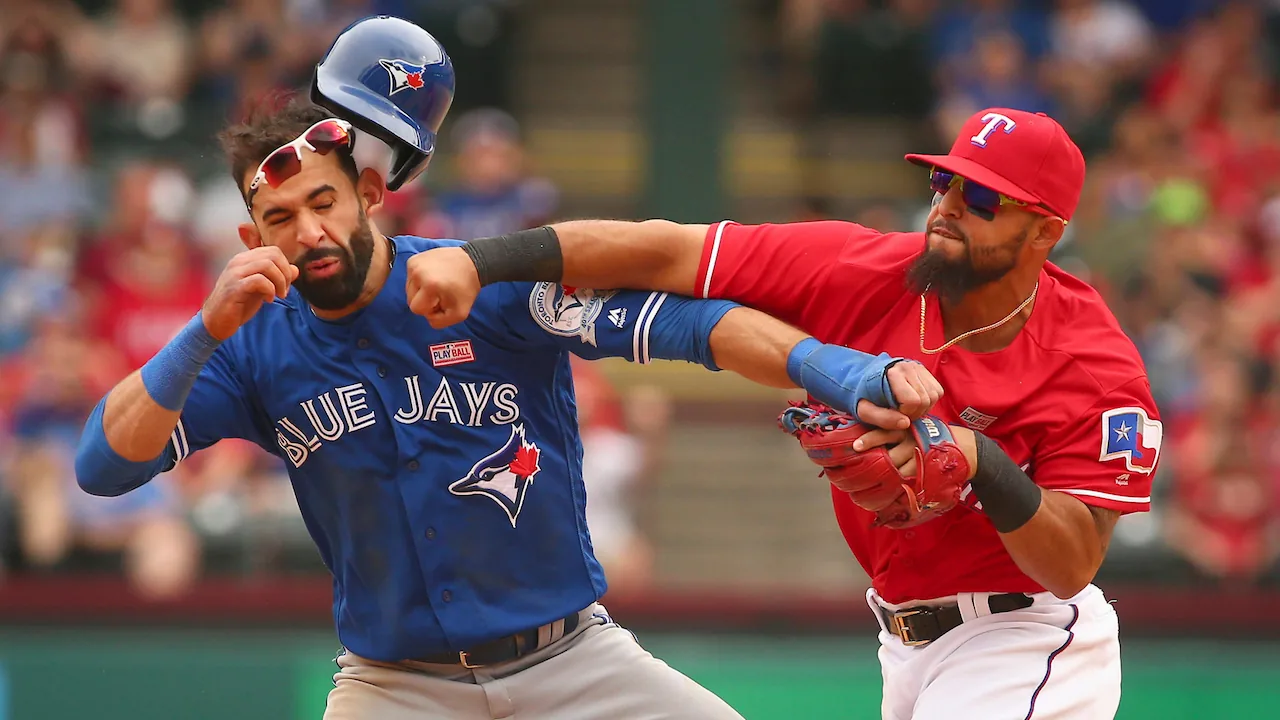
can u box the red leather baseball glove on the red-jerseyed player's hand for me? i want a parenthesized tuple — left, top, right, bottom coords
(778, 402, 969, 529)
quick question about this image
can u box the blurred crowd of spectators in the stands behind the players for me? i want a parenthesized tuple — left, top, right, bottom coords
(0, 0, 1280, 596)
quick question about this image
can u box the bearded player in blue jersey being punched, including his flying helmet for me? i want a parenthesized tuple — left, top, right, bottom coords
(76, 18, 941, 720)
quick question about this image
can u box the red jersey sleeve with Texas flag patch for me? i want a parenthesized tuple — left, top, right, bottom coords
(1032, 378, 1164, 512)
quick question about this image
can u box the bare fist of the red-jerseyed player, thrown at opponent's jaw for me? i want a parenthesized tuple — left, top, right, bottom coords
(404, 247, 480, 329)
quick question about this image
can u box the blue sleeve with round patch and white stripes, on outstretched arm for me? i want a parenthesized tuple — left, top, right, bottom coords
(504, 282, 737, 370)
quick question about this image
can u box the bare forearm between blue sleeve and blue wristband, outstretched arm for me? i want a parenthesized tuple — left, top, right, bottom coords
(710, 307, 809, 388)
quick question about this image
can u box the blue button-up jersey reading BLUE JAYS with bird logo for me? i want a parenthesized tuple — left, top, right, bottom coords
(144, 237, 733, 660)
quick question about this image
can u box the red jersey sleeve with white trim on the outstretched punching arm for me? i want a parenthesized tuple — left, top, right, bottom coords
(695, 220, 919, 325)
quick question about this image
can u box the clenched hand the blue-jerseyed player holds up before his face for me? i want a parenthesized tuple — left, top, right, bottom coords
(201, 245, 298, 340)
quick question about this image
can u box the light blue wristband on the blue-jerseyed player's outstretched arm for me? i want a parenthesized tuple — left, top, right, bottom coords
(787, 337, 902, 418)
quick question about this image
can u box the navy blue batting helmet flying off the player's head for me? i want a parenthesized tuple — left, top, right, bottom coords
(311, 15, 454, 191)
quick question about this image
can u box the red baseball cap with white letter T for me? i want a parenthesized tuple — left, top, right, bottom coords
(906, 108, 1084, 220)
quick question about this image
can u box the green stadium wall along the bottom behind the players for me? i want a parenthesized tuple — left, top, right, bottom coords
(0, 626, 1280, 720)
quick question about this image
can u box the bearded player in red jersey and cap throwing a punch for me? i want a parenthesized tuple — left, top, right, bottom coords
(407, 109, 1162, 720)
